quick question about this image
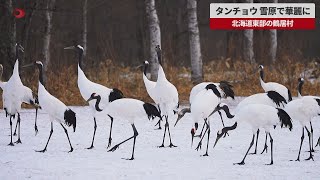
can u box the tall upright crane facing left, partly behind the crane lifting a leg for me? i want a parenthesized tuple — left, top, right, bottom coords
(64, 45, 123, 149)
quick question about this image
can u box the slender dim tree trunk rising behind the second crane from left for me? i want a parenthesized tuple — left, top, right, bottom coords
(42, 0, 55, 83)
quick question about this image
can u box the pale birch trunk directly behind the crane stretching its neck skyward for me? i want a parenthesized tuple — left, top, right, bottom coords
(145, 0, 161, 80)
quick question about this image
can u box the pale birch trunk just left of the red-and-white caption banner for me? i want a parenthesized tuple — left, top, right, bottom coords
(187, 0, 203, 84)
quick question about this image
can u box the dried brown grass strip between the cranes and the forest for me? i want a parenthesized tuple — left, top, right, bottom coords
(4, 59, 320, 105)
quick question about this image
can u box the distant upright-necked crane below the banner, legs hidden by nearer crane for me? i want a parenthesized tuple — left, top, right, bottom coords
(259, 65, 292, 102)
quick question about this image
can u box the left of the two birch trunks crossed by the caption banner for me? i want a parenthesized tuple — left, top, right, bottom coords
(243, 0, 255, 63)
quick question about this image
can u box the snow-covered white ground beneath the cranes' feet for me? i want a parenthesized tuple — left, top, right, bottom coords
(0, 98, 320, 180)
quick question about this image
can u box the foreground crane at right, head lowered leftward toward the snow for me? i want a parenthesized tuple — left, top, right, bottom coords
(214, 104, 292, 165)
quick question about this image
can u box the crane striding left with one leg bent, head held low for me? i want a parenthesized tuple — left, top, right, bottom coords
(88, 93, 161, 160)
